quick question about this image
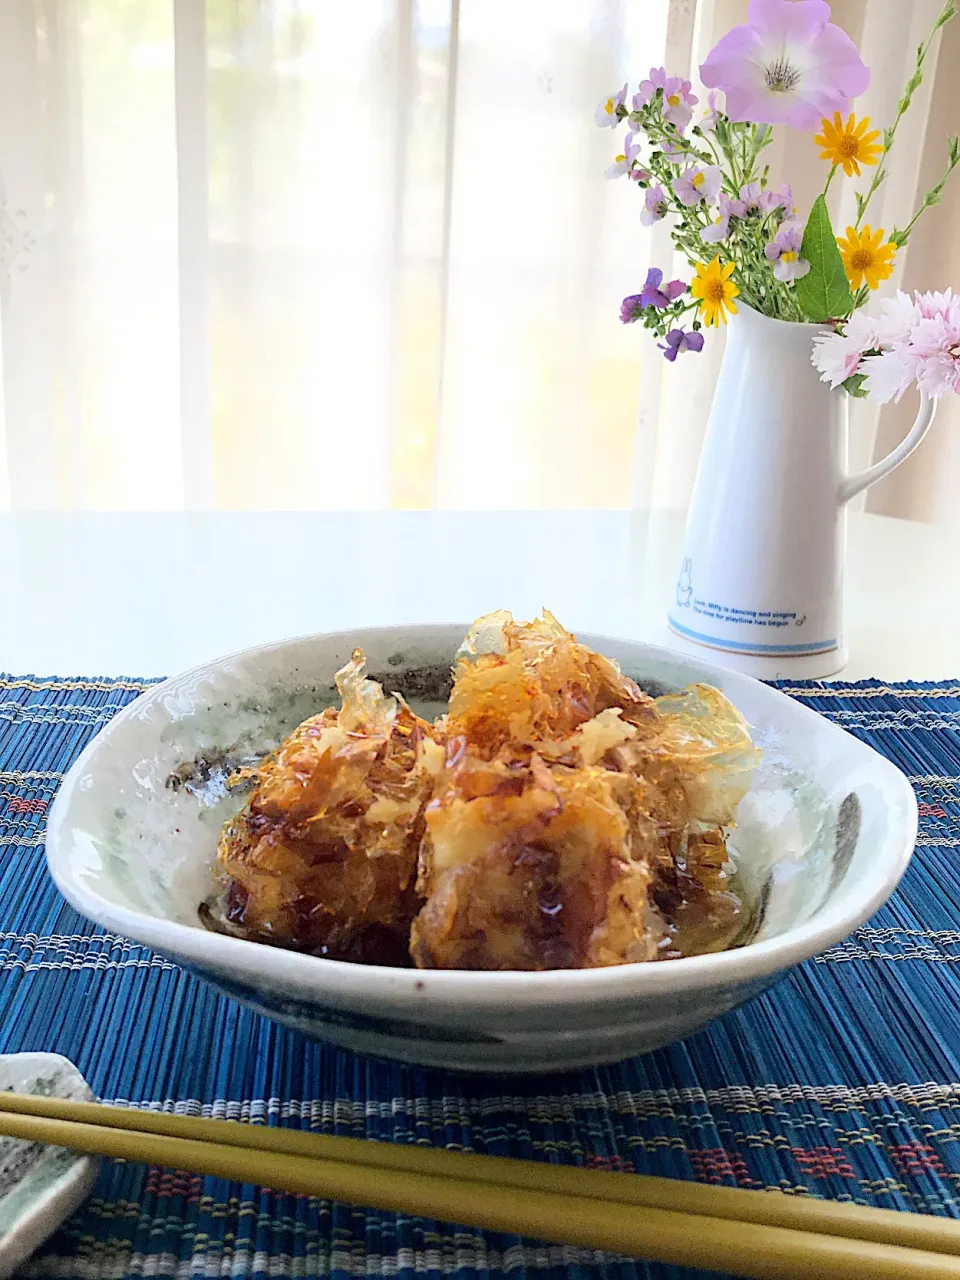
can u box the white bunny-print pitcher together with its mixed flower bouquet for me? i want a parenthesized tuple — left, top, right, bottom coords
(596, 0, 960, 677)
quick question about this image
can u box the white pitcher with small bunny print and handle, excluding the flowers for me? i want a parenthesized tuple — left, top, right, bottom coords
(669, 306, 936, 677)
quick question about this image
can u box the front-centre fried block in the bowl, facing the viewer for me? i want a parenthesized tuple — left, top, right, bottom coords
(411, 754, 662, 969)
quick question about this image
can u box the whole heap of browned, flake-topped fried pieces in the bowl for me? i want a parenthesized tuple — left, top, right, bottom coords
(219, 612, 758, 970)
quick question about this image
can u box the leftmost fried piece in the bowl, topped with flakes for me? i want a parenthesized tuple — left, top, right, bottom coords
(219, 650, 443, 964)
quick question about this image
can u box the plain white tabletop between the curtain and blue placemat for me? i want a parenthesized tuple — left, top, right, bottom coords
(0, 511, 960, 680)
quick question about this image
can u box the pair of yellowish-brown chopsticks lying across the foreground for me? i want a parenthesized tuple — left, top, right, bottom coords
(0, 1093, 960, 1280)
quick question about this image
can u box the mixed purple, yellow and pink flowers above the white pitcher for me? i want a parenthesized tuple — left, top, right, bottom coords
(604, 0, 960, 398)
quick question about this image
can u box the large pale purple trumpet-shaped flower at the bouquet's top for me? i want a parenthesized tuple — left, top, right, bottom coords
(700, 0, 870, 133)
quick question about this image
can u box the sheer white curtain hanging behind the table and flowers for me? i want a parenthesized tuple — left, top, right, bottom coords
(0, 0, 960, 518)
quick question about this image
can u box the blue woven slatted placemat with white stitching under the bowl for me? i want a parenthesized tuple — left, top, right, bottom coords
(0, 677, 960, 1280)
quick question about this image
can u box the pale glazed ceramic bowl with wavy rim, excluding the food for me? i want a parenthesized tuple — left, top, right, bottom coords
(46, 626, 916, 1073)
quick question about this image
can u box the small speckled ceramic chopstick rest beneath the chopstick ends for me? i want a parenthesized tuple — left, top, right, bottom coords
(0, 1053, 100, 1277)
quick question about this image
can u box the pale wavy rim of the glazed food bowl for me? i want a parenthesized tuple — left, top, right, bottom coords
(45, 623, 918, 1012)
